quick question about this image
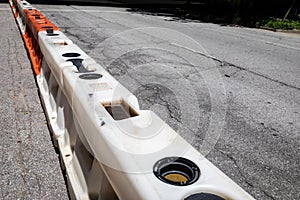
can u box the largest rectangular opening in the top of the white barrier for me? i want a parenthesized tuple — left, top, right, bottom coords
(102, 100, 138, 120)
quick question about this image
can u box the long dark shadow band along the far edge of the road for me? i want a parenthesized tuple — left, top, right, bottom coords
(12, 0, 300, 27)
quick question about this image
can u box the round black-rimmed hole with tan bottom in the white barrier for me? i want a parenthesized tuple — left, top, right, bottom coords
(153, 157, 200, 186)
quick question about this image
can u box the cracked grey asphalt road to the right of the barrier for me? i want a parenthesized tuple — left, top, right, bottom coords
(34, 2, 300, 200)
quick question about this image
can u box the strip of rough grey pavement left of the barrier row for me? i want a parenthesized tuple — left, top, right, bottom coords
(0, 3, 68, 199)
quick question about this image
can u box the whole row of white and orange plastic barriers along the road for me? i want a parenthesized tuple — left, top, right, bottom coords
(11, 0, 253, 200)
